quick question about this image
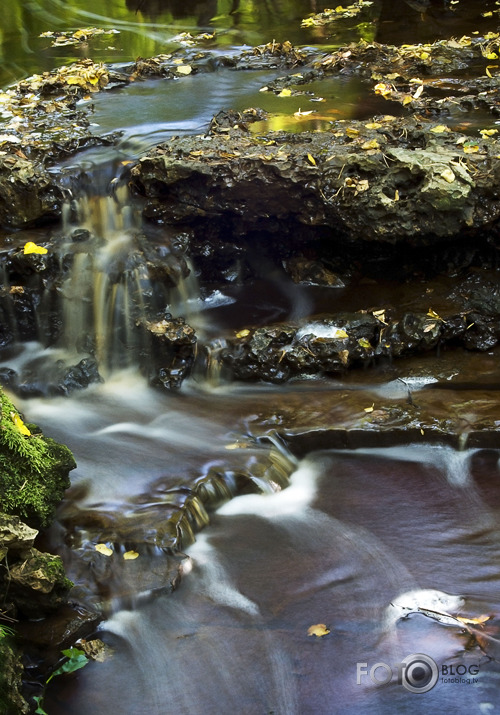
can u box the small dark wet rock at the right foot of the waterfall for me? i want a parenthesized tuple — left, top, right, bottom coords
(140, 314, 197, 390)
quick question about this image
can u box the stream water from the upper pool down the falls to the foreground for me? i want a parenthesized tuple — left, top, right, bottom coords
(0, 0, 500, 715)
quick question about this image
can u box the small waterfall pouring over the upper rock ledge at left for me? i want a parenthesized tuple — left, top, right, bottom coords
(52, 169, 201, 377)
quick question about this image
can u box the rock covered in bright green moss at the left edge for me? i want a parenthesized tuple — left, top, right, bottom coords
(0, 389, 76, 528)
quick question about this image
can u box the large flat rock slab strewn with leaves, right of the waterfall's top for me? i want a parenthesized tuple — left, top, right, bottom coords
(131, 117, 500, 246)
